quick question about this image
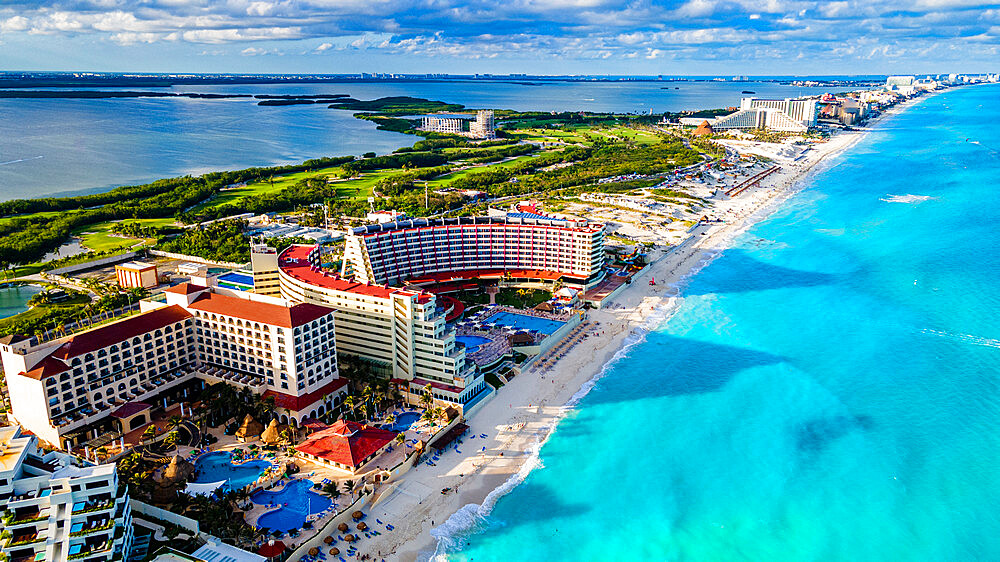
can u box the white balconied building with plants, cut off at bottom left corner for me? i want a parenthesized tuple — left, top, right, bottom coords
(0, 426, 133, 562)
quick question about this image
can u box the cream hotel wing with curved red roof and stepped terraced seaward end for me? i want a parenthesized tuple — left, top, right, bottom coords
(268, 246, 492, 407)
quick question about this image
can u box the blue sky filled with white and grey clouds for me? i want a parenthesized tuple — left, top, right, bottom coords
(0, 0, 1000, 75)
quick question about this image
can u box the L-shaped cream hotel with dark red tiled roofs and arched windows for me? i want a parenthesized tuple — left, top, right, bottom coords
(0, 283, 347, 448)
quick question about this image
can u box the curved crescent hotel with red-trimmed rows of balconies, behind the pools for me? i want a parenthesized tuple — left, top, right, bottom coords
(342, 213, 604, 287)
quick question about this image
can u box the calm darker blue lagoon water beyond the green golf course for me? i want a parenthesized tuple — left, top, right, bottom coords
(0, 81, 826, 200)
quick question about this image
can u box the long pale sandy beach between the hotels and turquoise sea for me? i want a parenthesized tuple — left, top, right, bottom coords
(354, 96, 930, 562)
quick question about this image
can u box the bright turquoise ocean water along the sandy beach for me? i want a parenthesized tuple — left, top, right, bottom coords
(436, 85, 1000, 561)
